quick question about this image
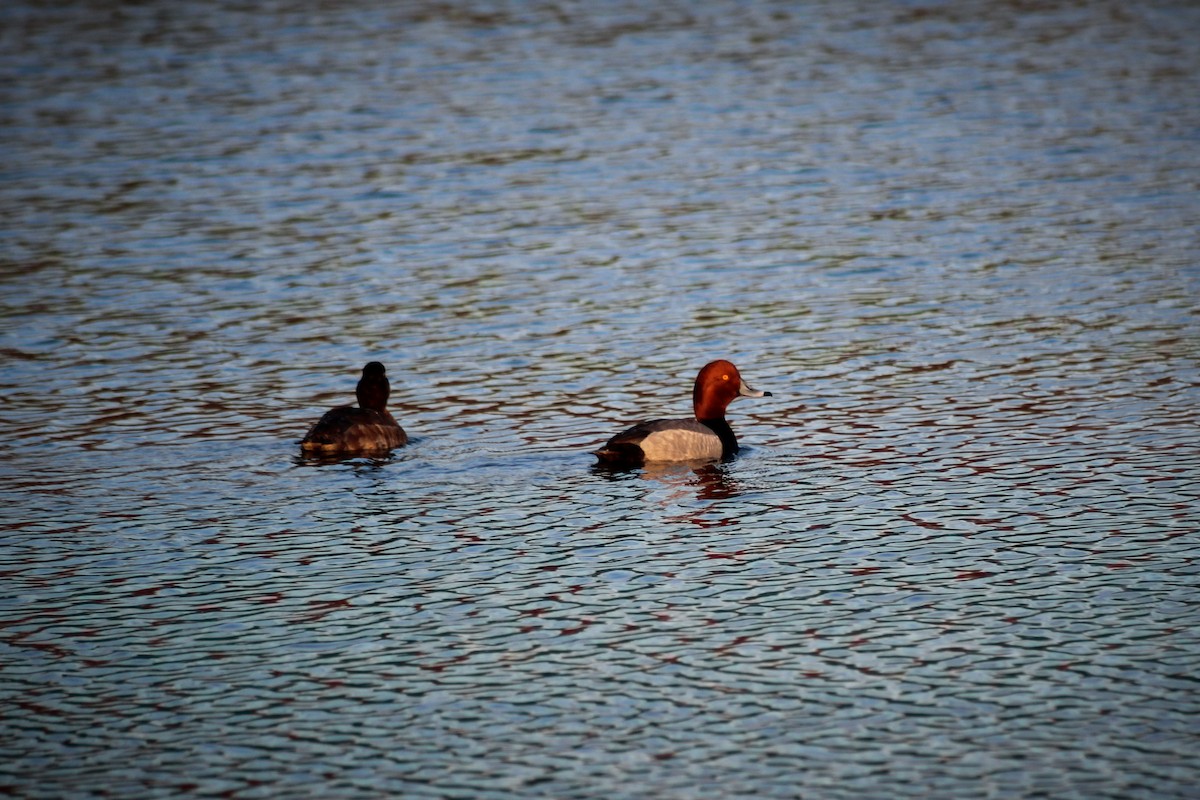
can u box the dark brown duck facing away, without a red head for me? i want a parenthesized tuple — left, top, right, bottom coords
(300, 361, 408, 455)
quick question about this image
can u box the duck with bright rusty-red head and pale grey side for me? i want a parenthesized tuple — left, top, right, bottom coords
(595, 361, 770, 464)
